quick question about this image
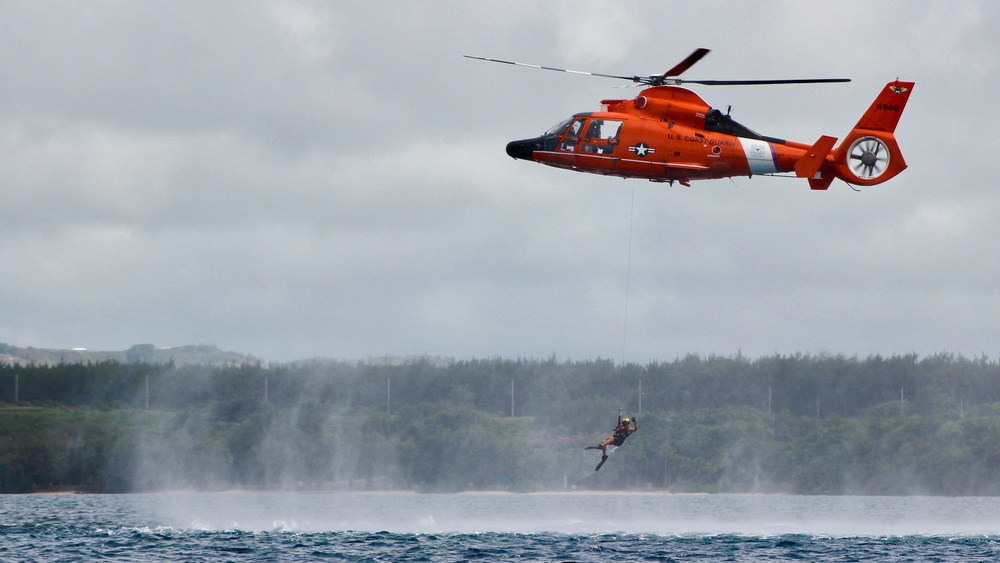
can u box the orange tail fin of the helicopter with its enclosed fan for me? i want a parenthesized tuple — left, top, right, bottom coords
(824, 80, 914, 189)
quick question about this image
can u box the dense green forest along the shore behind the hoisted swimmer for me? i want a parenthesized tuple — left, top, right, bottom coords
(0, 354, 1000, 495)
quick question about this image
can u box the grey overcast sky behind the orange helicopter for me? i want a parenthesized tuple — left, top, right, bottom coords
(0, 0, 1000, 363)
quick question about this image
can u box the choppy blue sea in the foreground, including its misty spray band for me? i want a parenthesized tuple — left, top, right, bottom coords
(0, 492, 1000, 562)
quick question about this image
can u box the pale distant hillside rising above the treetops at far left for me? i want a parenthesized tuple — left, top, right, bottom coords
(0, 342, 260, 366)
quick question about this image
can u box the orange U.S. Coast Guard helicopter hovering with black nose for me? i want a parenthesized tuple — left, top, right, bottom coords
(465, 49, 914, 190)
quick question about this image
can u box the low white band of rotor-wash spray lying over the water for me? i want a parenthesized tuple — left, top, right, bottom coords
(148, 492, 1000, 537)
